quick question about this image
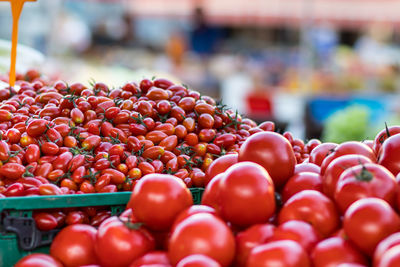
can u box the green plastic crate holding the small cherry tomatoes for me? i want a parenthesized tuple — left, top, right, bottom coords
(0, 188, 204, 267)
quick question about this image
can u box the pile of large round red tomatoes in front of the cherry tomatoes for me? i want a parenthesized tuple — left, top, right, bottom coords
(16, 118, 400, 267)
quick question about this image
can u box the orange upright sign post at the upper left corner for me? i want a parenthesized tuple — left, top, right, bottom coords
(0, 0, 36, 87)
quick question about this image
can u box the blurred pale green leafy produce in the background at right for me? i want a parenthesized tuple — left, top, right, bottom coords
(321, 105, 400, 143)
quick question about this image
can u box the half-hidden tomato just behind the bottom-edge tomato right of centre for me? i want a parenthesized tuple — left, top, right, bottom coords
(269, 220, 321, 253)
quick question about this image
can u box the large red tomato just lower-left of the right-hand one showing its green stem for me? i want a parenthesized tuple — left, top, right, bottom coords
(278, 190, 339, 237)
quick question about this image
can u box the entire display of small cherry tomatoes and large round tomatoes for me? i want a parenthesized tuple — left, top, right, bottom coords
(0, 72, 400, 267)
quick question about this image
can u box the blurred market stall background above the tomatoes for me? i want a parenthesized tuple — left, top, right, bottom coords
(0, 0, 400, 142)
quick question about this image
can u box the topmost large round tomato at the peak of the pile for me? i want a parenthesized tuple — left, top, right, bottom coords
(239, 132, 296, 188)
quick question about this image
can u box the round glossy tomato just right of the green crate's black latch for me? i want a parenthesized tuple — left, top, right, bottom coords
(50, 224, 98, 267)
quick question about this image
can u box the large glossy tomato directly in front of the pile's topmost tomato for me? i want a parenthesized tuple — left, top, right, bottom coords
(219, 162, 276, 227)
